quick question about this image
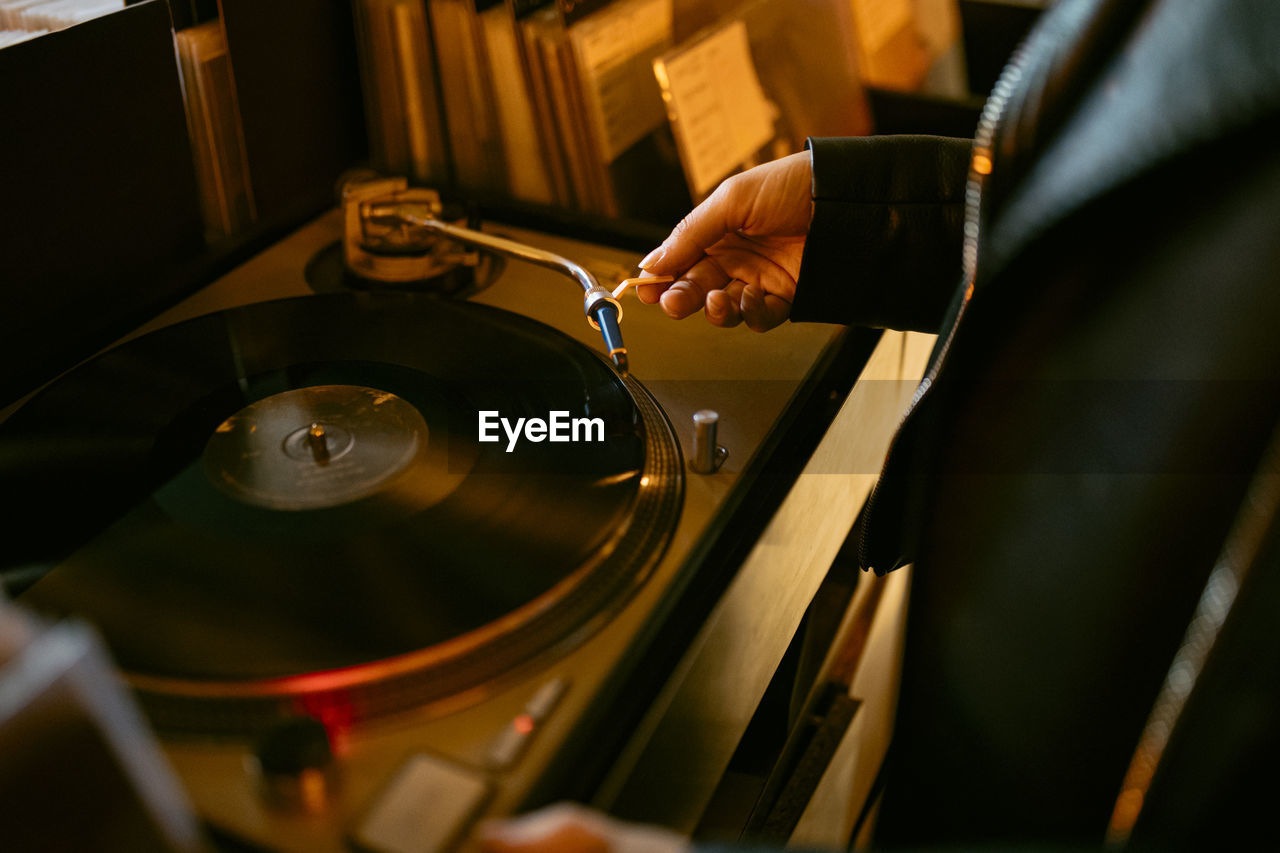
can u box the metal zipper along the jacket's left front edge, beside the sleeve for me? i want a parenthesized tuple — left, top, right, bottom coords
(858, 42, 1030, 569)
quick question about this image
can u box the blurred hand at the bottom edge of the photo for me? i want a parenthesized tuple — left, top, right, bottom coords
(479, 803, 690, 853)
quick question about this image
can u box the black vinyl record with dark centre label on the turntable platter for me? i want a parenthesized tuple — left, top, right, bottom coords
(0, 293, 682, 730)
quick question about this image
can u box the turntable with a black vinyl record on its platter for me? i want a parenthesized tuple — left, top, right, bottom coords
(0, 201, 925, 850)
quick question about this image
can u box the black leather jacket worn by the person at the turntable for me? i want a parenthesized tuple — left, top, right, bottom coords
(792, 0, 1280, 847)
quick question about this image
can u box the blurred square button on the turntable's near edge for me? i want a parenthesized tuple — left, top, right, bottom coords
(351, 754, 489, 853)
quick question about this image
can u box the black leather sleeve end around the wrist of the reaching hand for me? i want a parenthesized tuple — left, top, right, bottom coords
(791, 136, 972, 332)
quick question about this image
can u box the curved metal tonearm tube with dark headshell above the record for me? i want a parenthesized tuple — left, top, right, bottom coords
(361, 201, 627, 375)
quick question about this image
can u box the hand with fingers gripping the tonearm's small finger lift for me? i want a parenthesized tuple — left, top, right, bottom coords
(636, 151, 813, 332)
